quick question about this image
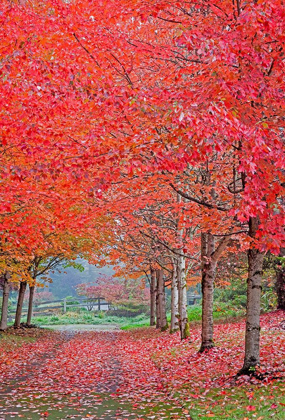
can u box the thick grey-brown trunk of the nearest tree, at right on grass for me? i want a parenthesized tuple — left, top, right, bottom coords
(239, 217, 264, 374)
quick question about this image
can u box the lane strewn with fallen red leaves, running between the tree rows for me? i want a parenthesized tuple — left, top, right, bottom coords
(0, 328, 137, 420)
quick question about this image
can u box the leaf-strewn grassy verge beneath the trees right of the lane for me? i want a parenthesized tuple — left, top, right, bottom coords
(146, 311, 285, 420)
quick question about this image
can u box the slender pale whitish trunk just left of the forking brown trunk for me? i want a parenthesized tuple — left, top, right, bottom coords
(177, 256, 190, 340)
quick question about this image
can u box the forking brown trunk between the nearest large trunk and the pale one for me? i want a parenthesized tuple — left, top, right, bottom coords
(200, 232, 216, 352)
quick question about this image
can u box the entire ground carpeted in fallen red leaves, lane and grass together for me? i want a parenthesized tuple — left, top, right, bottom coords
(0, 311, 285, 420)
